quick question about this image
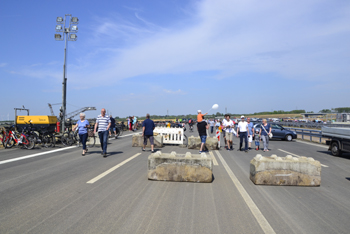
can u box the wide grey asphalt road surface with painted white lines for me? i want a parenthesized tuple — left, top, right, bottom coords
(0, 128, 350, 234)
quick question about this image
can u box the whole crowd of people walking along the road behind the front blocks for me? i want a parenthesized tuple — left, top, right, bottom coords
(73, 108, 271, 157)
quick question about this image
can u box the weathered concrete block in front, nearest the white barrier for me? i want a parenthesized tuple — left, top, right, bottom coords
(148, 151, 213, 183)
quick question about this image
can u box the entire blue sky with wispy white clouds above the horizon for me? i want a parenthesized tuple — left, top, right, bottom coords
(0, 0, 350, 120)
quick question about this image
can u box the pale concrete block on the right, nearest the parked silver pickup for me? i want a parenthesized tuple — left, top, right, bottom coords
(250, 154, 321, 186)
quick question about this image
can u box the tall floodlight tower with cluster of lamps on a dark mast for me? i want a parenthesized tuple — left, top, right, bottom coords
(55, 14, 79, 133)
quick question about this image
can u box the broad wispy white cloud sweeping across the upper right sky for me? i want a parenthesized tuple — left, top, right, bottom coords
(67, 0, 350, 85)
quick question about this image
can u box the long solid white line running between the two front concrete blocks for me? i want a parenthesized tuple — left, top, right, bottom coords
(215, 150, 275, 233)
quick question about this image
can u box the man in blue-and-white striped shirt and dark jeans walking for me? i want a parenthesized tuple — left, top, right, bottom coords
(94, 108, 111, 158)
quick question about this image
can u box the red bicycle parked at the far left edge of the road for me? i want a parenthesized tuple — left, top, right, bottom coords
(3, 123, 36, 149)
